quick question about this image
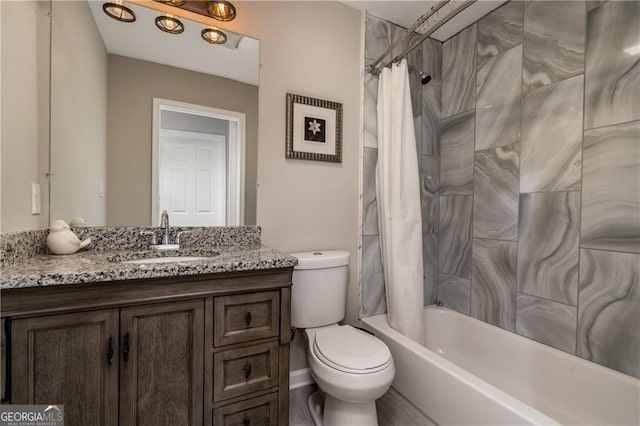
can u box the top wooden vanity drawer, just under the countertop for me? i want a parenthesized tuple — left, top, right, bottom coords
(213, 291, 280, 346)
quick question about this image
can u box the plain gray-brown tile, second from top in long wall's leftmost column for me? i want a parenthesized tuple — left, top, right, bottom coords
(440, 111, 476, 195)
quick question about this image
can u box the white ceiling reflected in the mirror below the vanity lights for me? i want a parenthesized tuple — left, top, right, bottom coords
(88, 0, 260, 86)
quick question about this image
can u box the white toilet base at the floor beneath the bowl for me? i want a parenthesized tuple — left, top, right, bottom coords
(308, 391, 378, 426)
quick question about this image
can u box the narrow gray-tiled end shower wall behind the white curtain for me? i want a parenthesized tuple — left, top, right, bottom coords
(360, 15, 442, 317)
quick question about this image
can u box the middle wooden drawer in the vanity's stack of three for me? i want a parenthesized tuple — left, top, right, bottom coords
(213, 342, 278, 402)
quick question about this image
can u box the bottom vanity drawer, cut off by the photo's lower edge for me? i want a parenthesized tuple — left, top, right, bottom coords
(213, 393, 278, 426)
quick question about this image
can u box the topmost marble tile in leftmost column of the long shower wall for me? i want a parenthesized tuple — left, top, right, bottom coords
(442, 24, 477, 118)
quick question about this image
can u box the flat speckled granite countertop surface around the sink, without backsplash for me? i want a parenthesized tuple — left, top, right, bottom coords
(0, 244, 298, 290)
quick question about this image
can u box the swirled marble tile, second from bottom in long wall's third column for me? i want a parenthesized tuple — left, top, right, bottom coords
(518, 192, 580, 305)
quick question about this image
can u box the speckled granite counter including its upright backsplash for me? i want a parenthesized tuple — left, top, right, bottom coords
(0, 227, 297, 290)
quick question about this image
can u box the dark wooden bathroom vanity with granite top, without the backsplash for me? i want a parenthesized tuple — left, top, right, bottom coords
(1, 226, 295, 426)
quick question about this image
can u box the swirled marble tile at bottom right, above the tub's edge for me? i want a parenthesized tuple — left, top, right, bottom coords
(577, 250, 640, 378)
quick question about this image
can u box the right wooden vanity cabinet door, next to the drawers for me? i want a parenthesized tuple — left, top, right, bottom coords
(120, 300, 204, 426)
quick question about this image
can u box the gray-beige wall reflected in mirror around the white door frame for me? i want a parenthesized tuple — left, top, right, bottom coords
(107, 55, 258, 226)
